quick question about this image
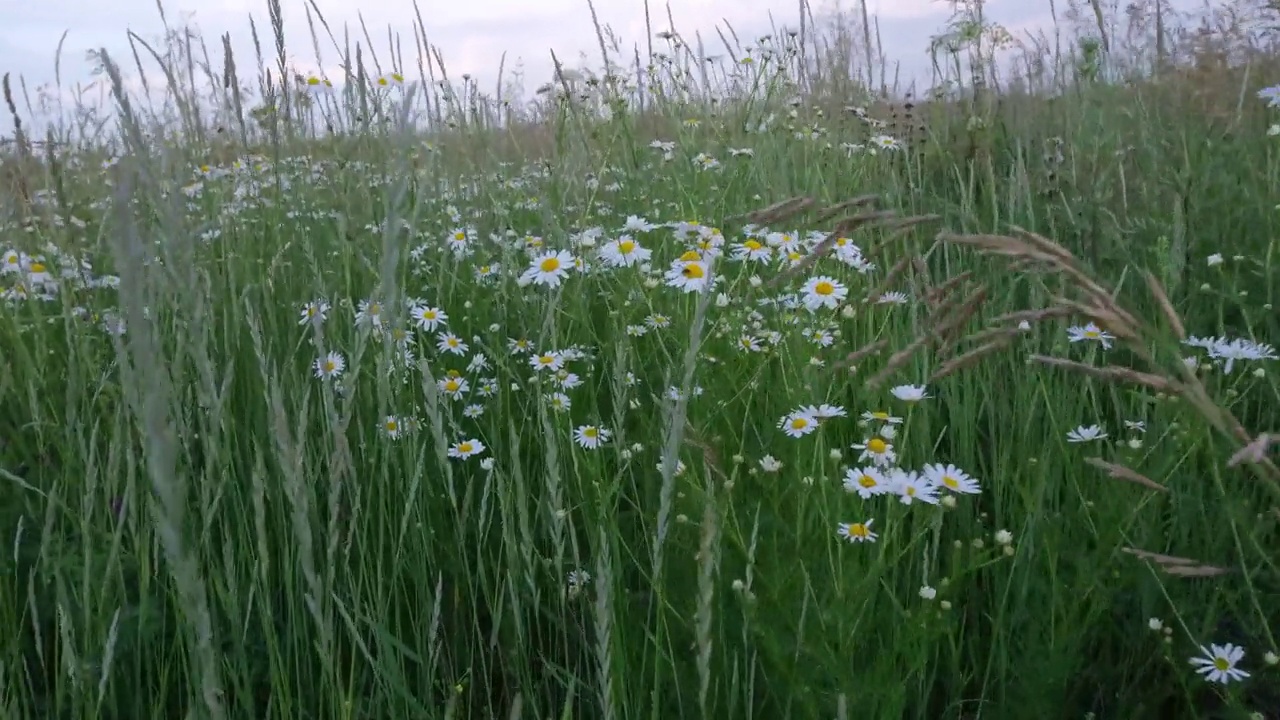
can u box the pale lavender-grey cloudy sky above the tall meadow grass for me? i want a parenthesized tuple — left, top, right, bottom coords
(0, 0, 1194, 136)
